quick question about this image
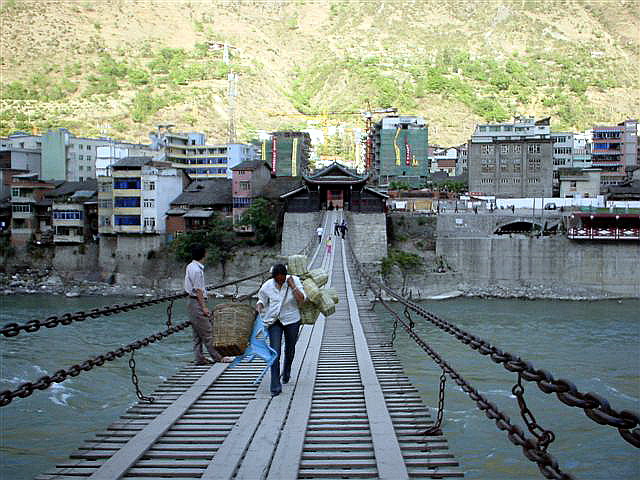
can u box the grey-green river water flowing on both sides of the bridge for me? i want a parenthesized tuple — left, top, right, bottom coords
(0, 295, 640, 480)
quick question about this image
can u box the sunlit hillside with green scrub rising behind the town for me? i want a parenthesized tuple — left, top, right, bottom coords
(0, 0, 640, 144)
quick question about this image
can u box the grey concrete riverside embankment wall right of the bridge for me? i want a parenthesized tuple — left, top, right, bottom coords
(436, 214, 640, 297)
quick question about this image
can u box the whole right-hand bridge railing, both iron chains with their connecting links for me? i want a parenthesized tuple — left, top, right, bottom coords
(346, 234, 640, 479)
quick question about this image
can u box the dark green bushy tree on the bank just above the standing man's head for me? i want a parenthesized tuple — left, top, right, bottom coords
(170, 215, 236, 277)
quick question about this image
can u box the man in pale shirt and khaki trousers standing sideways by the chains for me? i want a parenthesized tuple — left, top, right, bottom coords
(184, 244, 233, 365)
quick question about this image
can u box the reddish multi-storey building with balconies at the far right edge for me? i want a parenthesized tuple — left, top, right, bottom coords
(591, 119, 638, 189)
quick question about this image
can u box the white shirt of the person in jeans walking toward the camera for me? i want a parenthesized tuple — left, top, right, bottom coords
(258, 275, 307, 326)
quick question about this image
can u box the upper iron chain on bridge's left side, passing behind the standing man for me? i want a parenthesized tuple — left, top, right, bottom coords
(0, 271, 266, 337)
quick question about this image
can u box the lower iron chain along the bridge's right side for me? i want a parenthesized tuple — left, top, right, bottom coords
(380, 300, 574, 480)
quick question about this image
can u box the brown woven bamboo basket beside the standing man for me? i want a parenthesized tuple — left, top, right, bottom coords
(211, 303, 256, 356)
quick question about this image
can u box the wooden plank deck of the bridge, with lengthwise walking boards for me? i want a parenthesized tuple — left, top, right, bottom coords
(36, 212, 463, 480)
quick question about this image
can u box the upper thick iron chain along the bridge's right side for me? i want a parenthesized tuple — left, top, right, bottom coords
(347, 238, 640, 448)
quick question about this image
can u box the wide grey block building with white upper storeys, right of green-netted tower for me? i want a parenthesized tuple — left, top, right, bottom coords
(468, 117, 553, 198)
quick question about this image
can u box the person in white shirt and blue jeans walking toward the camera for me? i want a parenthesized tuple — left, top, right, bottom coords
(256, 263, 307, 397)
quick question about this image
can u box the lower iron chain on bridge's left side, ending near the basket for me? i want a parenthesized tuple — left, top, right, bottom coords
(0, 321, 191, 407)
